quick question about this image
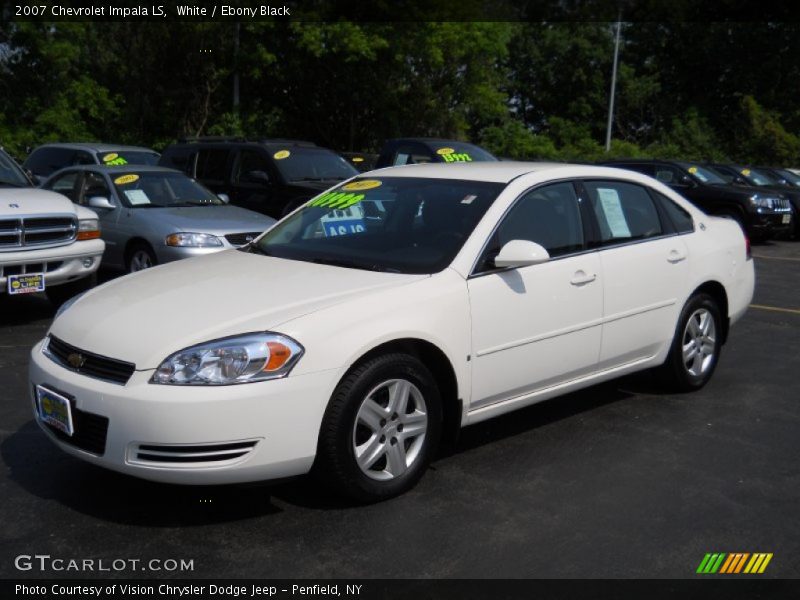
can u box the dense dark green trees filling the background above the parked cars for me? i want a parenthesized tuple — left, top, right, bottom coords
(0, 21, 800, 165)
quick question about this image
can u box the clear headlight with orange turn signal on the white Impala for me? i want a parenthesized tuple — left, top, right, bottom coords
(150, 333, 303, 385)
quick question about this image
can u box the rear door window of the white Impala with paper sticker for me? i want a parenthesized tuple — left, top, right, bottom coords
(584, 181, 663, 244)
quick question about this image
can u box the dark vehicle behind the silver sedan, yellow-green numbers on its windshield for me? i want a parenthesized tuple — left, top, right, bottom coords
(22, 143, 159, 183)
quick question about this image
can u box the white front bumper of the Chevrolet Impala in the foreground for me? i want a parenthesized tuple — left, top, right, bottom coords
(29, 342, 338, 484)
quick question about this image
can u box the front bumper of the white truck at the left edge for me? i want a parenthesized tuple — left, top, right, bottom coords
(0, 239, 106, 294)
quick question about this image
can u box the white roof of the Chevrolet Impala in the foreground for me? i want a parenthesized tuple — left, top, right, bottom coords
(366, 161, 652, 183)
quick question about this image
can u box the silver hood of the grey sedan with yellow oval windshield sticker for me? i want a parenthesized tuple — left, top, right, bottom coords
(150, 204, 275, 234)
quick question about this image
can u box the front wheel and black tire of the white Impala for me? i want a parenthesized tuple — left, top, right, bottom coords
(313, 353, 442, 503)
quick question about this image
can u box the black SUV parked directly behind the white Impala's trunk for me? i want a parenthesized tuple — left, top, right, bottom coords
(599, 159, 794, 240)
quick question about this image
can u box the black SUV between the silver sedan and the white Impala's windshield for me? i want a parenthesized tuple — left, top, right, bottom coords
(158, 137, 358, 219)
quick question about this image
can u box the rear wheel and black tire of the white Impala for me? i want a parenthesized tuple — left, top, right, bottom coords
(658, 293, 723, 392)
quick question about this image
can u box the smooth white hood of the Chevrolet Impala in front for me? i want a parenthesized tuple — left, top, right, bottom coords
(50, 250, 428, 370)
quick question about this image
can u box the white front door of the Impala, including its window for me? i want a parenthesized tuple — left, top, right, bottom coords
(468, 182, 603, 410)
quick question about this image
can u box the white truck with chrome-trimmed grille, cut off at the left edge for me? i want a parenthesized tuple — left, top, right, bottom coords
(0, 149, 105, 305)
